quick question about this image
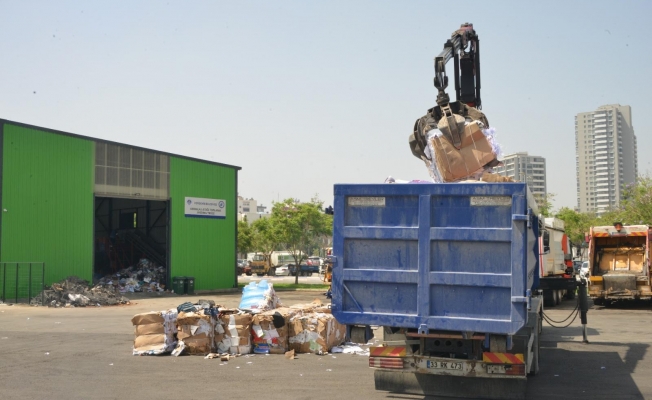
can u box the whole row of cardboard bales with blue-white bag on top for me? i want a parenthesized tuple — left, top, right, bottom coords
(132, 281, 346, 361)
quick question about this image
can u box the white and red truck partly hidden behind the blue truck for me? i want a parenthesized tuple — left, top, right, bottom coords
(539, 217, 577, 307)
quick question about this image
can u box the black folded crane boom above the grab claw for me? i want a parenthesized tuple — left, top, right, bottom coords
(434, 22, 482, 109)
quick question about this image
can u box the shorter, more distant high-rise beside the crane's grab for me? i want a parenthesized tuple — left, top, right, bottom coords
(494, 152, 548, 204)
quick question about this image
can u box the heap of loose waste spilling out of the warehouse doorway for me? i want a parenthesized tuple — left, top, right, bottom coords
(95, 258, 167, 293)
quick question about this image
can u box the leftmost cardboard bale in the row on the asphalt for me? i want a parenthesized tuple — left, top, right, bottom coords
(131, 309, 177, 356)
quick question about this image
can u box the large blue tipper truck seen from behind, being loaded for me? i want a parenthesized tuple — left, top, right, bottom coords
(331, 182, 586, 399)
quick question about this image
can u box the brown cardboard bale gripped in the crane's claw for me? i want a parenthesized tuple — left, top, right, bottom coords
(430, 122, 496, 182)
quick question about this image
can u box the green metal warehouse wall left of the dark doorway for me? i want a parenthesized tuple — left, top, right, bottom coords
(0, 122, 94, 284)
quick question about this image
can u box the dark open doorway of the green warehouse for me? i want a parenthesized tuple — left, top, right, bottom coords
(93, 197, 170, 284)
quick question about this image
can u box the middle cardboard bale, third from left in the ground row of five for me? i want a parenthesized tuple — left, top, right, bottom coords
(215, 310, 253, 354)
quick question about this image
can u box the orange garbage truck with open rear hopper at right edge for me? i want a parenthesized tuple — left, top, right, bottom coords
(586, 222, 652, 306)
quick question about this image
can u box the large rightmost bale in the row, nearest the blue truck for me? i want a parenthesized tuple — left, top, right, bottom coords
(289, 312, 346, 354)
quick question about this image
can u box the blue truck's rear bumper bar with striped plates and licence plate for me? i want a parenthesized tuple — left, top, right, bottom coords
(369, 351, 529, 380)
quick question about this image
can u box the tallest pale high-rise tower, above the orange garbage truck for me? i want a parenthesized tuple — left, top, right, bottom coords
(575, 104, 638, 215)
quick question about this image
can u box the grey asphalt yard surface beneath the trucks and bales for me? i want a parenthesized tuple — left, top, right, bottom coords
(0, 290, 652, 400)
